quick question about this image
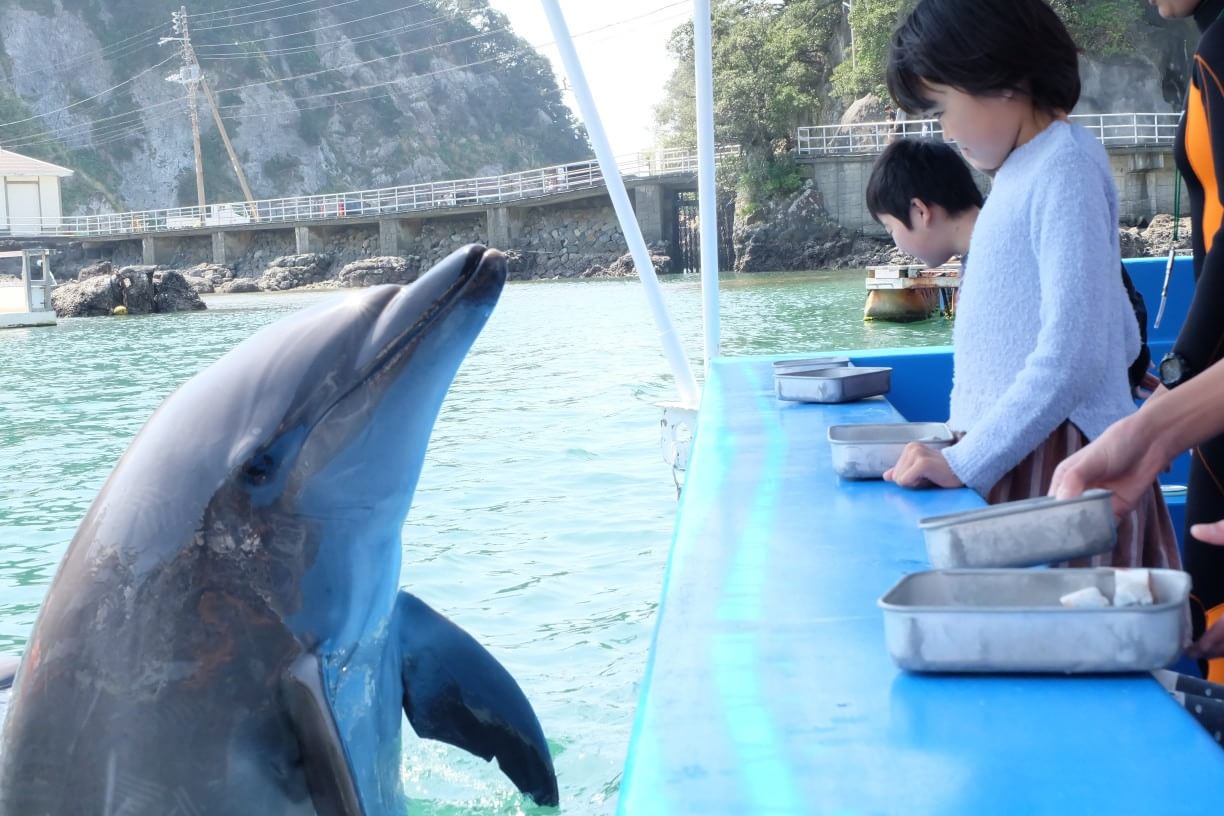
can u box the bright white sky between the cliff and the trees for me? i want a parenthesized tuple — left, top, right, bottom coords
(479, 0, 693, 155)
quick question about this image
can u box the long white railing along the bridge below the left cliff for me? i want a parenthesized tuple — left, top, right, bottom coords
(0, 146, 739, 237)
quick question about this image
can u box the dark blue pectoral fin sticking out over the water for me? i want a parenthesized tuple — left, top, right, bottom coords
(395, 592, 558, 806)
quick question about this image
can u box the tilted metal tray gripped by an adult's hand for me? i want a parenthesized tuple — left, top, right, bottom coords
(918, 489, 1118, 569)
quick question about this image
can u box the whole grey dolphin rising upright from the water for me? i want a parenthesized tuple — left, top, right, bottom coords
(0, 245, 558, 816)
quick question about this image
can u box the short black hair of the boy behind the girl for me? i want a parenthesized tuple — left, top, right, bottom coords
(867, 138, 982, 229)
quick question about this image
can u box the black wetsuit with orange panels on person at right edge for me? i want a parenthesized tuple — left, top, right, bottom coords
(1149, 0, 1224, 683)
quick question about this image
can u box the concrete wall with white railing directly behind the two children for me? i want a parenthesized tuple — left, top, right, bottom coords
(796, 113, 1189, 234)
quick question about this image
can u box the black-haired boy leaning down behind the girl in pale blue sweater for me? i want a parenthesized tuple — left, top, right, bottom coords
(867, 138, 1155, 391)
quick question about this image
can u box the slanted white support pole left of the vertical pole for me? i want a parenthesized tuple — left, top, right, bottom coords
(541, 0, 700, 409)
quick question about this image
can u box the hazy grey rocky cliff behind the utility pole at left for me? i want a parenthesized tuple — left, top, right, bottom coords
(0, 0, 589, 213)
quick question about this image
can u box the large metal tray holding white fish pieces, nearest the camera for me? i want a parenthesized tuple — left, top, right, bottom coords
(880, 568, 1190, 674)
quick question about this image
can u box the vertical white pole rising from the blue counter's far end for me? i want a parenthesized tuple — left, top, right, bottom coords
(693, 0, 720, 373)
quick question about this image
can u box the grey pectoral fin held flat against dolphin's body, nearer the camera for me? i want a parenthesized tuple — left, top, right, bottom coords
(280, 652, 365, 816)
